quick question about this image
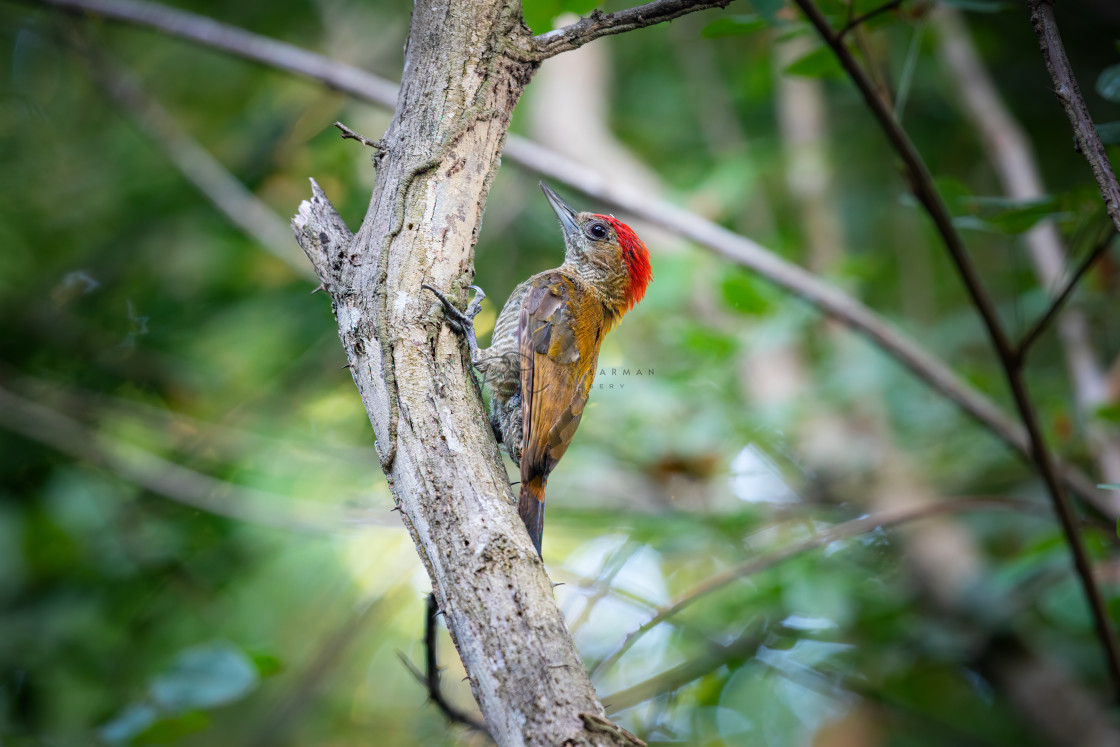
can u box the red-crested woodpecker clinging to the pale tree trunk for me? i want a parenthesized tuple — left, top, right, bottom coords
(423, 181, 653, 554)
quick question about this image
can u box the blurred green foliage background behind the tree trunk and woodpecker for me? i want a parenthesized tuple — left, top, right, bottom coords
(0, 0, 1120, 747)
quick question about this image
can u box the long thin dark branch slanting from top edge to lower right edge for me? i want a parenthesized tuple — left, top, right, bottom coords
(794, 0, 1120, 698)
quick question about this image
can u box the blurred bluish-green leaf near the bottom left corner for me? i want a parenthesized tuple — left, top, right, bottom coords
(150, 642, 260, 712)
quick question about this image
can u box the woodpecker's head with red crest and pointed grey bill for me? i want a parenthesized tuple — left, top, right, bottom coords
(541, 181, 653, 316)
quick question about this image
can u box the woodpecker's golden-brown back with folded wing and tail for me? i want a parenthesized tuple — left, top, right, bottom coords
(517, 271, 604, 552)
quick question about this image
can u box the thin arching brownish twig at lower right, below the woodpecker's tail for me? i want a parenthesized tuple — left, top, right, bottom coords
(591, 498, 1051, 676)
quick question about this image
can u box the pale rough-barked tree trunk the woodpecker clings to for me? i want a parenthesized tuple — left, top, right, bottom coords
(292, 0, 636, 746)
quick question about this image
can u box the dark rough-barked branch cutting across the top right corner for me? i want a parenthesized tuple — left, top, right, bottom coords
(1028, 0, 1120, 236)
